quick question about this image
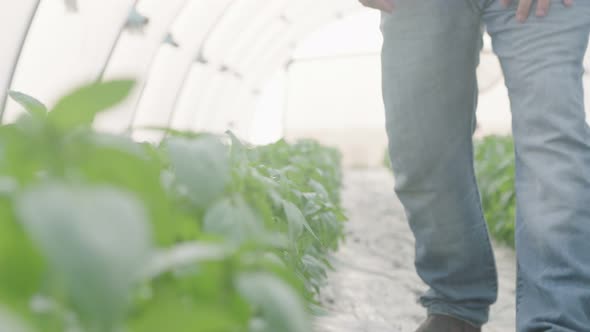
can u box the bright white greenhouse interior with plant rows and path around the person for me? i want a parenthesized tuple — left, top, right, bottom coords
(0, 0, 590, 332)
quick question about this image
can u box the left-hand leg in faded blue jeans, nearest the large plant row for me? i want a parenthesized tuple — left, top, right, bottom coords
(381, 0, 497, 326)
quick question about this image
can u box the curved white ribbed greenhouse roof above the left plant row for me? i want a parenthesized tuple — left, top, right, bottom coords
(0, 0, 360, 137)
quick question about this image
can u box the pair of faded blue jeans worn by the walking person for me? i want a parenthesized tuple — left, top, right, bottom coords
(381, 0, 590, 332)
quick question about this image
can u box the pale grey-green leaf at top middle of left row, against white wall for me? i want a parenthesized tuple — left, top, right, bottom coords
(166, 136, 231, 208)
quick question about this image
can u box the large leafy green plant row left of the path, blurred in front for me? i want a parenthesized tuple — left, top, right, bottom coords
(0, 81, 345, 332)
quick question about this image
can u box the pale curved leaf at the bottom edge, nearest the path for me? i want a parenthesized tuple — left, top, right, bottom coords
(236, 273, 312, 332)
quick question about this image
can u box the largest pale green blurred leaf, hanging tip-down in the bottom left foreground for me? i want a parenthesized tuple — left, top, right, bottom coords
(16, 183, 151, 331)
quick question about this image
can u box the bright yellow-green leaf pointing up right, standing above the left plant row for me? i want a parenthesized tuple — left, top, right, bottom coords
(48, 80, 135, 131)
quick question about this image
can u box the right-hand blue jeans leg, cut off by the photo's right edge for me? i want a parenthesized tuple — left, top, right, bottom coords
(484, 0, 590, 332)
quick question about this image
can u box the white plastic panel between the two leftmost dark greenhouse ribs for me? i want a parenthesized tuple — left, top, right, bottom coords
(3, 0, 135, 121)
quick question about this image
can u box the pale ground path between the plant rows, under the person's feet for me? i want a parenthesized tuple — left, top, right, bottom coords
(315, 169, 516, 332)
